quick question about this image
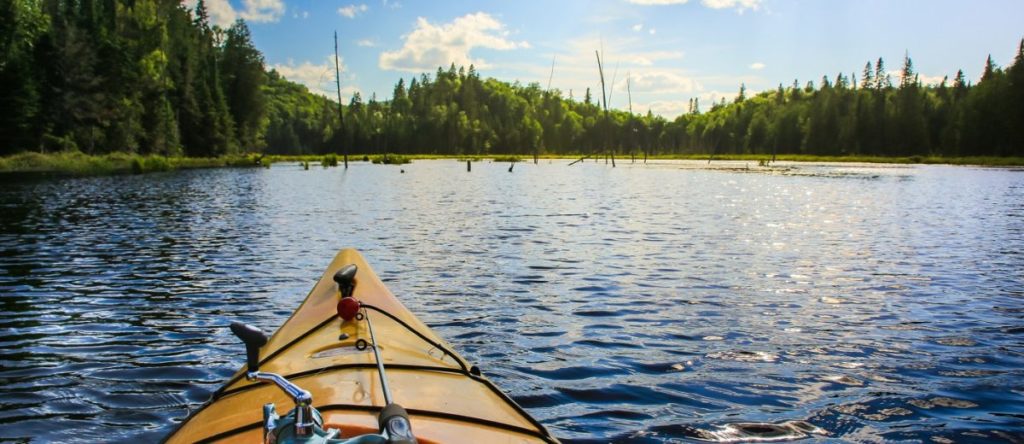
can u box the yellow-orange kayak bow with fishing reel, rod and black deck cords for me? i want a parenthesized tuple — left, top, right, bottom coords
(165, 249, 557, 444)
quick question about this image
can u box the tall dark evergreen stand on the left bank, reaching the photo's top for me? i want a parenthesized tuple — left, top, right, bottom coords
(0, 0, 267, 157)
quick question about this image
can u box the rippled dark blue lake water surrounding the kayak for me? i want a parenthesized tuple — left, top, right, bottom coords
(0, 161, 1024, 442)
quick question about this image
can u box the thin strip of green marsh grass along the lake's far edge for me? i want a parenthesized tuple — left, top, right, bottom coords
(0, 151, 1024, 177)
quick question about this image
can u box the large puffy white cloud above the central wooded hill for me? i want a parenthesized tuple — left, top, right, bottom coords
(379, 12, 529, 73)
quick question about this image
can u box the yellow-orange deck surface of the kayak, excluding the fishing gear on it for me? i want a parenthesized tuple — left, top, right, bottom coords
(167, 250, 555, 443)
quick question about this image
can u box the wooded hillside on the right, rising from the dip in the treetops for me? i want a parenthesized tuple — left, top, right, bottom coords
(665, 47, 1024, 159)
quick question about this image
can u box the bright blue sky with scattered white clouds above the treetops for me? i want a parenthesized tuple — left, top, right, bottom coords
(185, 0, 1024, 119)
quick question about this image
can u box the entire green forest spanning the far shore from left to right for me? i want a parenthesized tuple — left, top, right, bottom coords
(0, 0, 1024, 157)
